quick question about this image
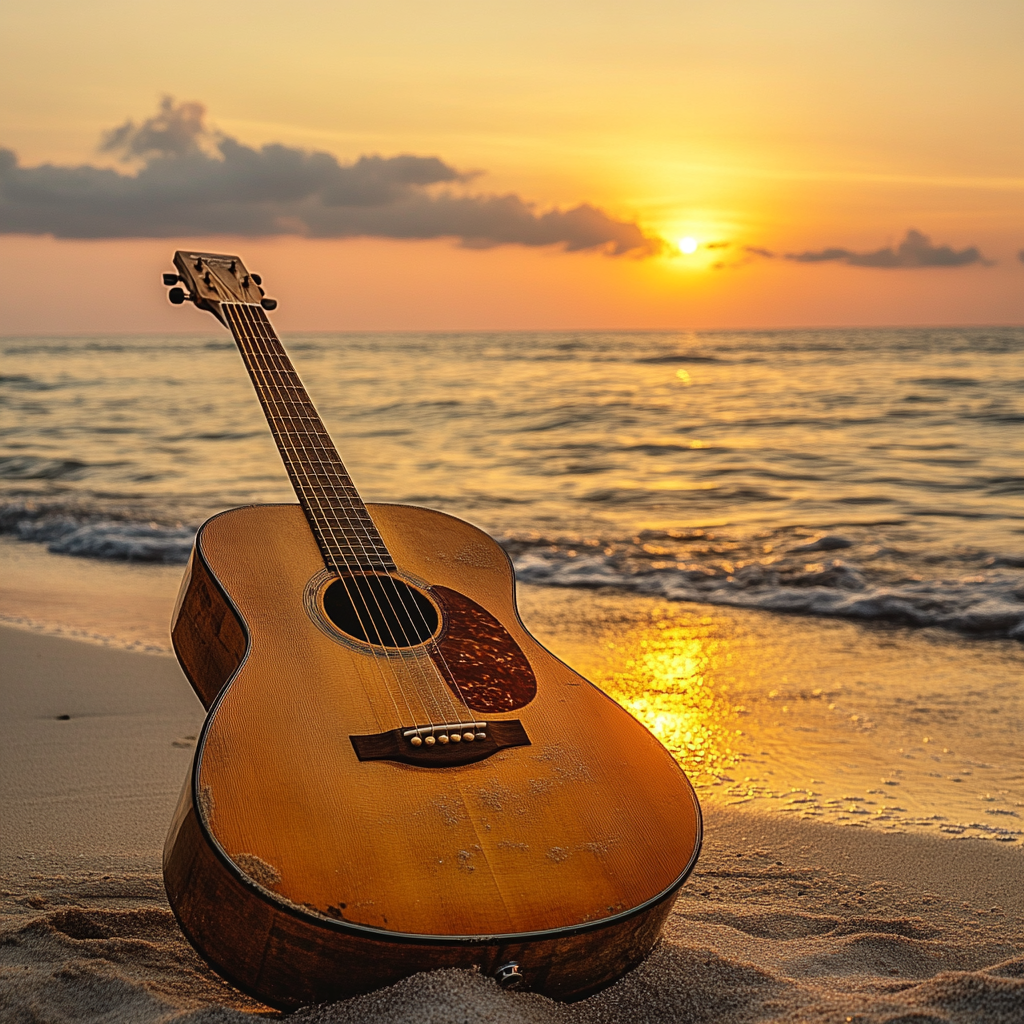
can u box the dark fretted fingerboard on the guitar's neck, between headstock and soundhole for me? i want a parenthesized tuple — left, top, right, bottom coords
(221, 302, 394, 572)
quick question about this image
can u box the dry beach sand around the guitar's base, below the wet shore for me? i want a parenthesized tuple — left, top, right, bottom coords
(0, 629, 1024, 1024)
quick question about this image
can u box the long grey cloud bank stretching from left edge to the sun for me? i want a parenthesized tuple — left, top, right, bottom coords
(0, 97, 666, 256)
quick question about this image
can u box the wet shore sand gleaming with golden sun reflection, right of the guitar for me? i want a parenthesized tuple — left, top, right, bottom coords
(520, 588, 1024, 843)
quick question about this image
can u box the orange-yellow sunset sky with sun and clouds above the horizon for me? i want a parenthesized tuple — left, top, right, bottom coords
(0, 0, 1024, 335)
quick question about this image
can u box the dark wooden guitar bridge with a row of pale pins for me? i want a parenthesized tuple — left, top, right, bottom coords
(348, 719, 529, 768)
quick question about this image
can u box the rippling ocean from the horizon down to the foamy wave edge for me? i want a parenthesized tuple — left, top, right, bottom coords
(0, 328, 1024, 639)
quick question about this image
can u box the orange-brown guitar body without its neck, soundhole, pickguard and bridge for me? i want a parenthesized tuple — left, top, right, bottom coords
(165, 506, 700, 1009)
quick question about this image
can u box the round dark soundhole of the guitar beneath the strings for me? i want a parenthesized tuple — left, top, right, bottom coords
(324, 574, 439, 647)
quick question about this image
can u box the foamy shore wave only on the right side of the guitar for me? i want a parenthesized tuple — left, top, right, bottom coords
(504, 529, 1024, 641)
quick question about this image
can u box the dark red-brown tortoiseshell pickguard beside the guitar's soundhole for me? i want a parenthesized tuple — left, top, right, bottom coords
(430, 587, 537, 714)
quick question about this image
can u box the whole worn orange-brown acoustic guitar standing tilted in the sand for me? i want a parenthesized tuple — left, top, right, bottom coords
(164, 251, 701, 1010)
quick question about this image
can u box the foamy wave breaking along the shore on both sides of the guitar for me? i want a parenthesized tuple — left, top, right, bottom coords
(0, 502, 1024, 641)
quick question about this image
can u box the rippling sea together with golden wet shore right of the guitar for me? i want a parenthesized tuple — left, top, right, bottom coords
(0, 328, 1024, 841)
